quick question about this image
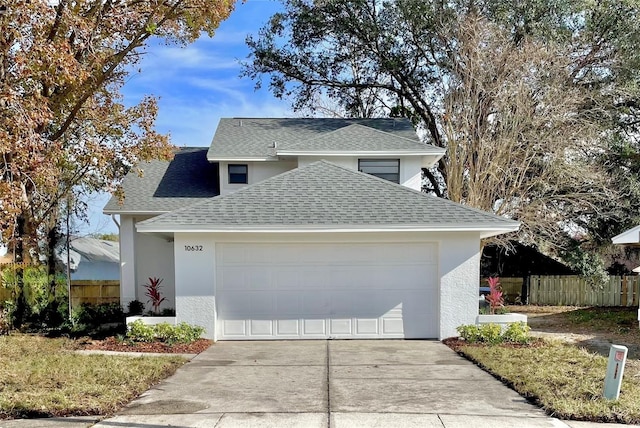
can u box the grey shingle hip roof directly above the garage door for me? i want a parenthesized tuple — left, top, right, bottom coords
(137, 161, 519, 236)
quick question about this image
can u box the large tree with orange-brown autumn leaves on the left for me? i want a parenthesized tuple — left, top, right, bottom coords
(0, 0, 234, 259)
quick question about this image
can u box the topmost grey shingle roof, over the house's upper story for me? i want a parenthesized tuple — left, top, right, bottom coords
(207, 118, 444, 161)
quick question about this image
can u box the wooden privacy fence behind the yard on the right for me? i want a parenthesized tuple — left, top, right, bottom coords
(527, 276, 640, 306)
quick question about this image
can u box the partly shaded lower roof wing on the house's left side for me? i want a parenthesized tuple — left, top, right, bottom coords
(103, 147, 220, 214)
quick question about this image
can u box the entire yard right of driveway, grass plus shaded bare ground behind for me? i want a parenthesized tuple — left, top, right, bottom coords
(446, 306, 640, 424)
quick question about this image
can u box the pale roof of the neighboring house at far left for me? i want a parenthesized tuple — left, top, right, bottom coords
(56, 237, 120, 270)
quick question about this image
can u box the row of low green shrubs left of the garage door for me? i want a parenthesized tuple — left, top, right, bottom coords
(126, 320, 204, 345)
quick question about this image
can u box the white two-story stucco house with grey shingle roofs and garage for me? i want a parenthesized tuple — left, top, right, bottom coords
(104, 118, 519, 340)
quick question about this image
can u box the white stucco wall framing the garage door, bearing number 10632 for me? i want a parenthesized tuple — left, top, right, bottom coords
(174, 232, 480, 339)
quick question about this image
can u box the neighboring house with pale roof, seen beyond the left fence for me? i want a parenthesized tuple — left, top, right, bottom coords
(55, 236, 120, 281)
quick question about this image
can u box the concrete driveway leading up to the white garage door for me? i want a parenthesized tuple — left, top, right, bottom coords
(97, 340, 580, 428)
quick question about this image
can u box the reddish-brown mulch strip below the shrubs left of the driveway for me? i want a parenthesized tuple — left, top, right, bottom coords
(77, 337, 213, 354)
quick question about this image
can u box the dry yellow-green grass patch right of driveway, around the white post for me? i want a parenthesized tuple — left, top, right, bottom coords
(458, 341, 640, 424)
